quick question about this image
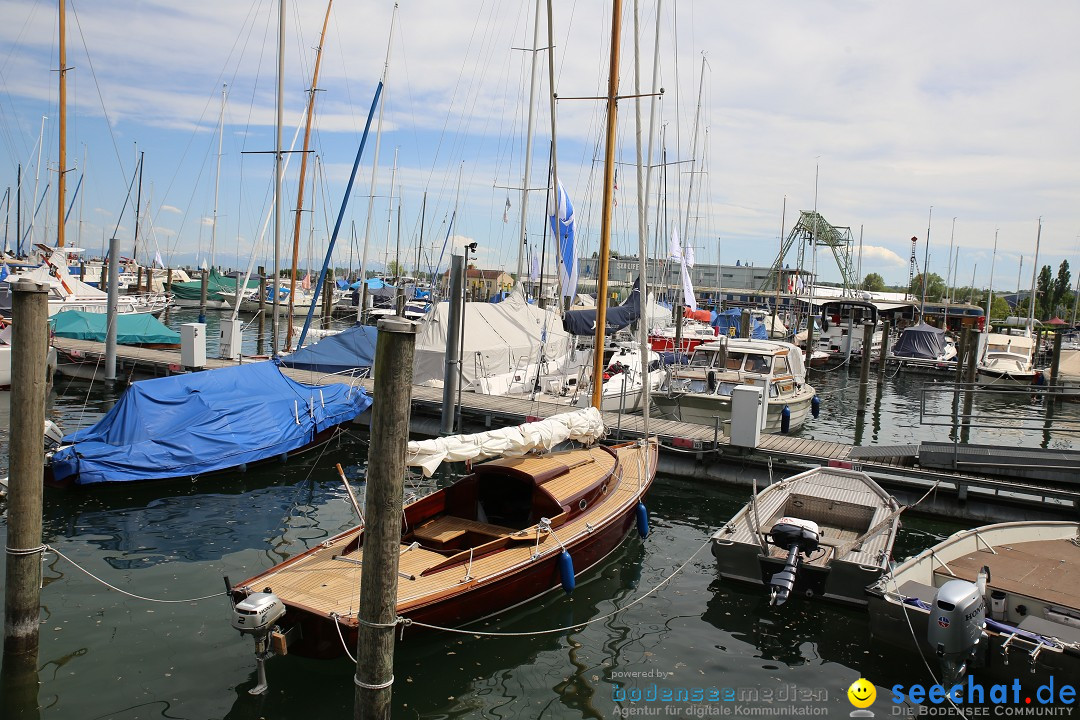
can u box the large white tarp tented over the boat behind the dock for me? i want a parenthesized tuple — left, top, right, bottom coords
(413, 290, 573, 388)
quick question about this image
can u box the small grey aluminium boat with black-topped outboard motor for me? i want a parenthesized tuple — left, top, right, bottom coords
(713, 467, 900, 607)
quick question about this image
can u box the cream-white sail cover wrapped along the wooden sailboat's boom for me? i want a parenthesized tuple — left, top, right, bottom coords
(405, 407, 604, 477)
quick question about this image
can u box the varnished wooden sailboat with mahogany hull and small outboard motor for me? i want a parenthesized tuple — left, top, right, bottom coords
(231, 418, 657, 657)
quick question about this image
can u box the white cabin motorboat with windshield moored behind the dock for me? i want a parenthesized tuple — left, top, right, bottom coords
(652, 337, 815, 432)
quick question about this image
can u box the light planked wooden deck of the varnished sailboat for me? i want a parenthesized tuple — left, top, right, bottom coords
(245, 446, 656, 620)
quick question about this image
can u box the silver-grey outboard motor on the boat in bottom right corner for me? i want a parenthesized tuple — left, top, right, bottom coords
(927, 580, 986, 688)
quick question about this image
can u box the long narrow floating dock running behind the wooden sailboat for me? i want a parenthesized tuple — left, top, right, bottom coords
(53, 338, 1080, 521)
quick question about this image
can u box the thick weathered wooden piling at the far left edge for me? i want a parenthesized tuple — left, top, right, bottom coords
(3, 280, 49, 666)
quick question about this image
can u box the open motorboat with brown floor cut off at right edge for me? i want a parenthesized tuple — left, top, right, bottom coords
(867, 520, 1080, 688)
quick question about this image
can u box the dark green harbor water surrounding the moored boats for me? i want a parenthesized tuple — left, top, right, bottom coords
(0, 315, 1080, 720)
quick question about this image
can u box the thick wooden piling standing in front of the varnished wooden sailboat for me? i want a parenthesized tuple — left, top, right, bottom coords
(353, 317, 417, 720)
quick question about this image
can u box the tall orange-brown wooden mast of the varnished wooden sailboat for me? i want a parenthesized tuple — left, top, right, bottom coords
(596, 0, 622, 409)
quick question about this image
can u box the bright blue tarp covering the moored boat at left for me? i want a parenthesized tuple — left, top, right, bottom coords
(52, 362, 372, 485)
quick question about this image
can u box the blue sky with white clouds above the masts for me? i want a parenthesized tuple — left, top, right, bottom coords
(0, 0, 1080, 289)
